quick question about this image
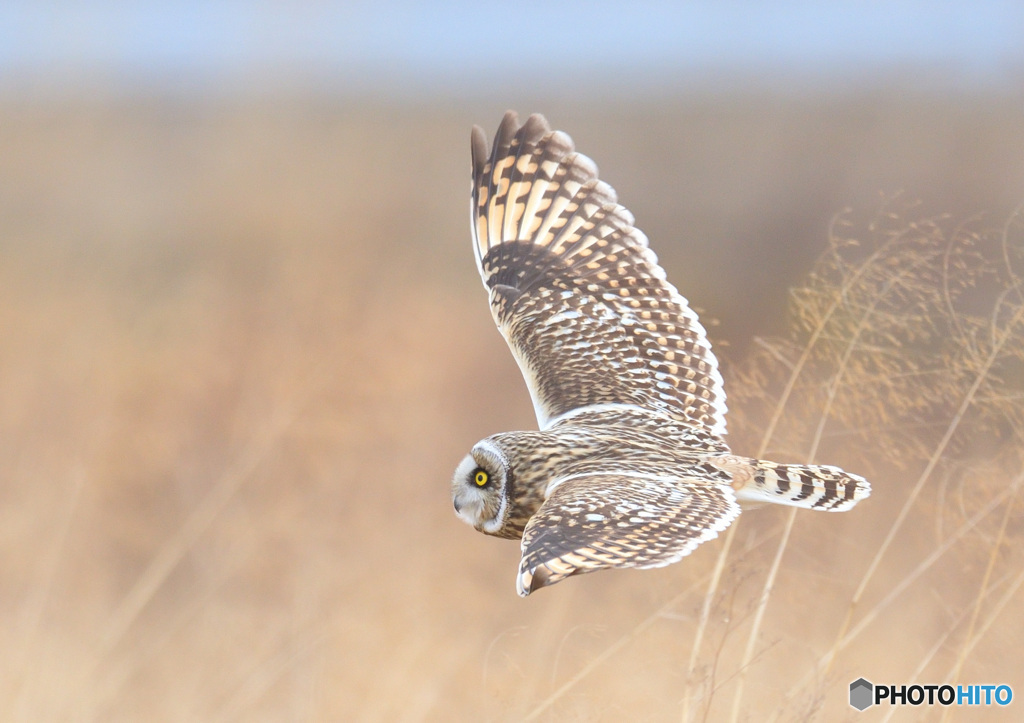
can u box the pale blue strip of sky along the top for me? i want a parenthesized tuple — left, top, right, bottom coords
(0, 0, 1024, 93)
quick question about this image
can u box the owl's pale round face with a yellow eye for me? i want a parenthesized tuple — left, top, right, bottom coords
(452, 439, 512, 535)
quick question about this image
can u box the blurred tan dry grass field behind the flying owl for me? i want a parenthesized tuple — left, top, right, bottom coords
(0, 92, 1024, 720)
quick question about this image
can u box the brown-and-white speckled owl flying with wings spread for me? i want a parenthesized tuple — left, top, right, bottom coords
(452, 112, 870, 597)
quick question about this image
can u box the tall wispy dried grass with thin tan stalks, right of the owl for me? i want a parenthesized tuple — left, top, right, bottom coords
(535, 200, 1024, 720)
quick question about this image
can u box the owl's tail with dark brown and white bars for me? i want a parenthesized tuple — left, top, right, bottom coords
(709, 456, 871, 512)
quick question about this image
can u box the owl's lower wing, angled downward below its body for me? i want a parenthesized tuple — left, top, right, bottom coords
(516, 470, 739, 596)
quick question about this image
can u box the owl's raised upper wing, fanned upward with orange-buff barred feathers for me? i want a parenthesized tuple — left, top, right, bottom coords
(472, 113, 726, 434)
